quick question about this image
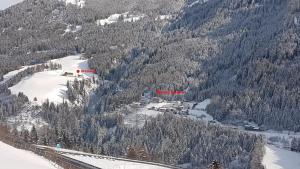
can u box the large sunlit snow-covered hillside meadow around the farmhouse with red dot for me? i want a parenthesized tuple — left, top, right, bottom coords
(9, 55, 93, 104)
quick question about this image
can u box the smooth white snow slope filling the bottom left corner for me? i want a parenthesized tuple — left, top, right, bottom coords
(0, 142, 60, 169)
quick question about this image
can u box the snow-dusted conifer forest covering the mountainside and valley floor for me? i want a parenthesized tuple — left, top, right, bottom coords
(0, 0, 300, 169)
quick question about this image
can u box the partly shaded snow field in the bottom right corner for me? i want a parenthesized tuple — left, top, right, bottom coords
(262, 145, 300, 169)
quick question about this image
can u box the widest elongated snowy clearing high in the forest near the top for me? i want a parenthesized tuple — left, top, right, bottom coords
(96, 12, 145, 26)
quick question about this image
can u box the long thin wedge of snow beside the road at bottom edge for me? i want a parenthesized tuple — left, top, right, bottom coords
(65, 154, 167, 169)
